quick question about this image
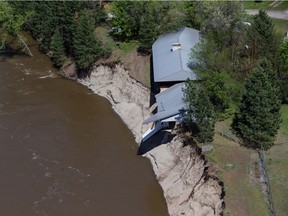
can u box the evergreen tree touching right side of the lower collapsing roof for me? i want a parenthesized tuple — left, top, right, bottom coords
(183, 80, 215, 143)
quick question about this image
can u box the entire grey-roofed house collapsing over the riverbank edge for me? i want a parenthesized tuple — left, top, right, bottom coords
(142, 27, 200, 141)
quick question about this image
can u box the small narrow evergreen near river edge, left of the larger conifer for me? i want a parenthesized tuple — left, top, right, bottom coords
(50, 30, 65, 67)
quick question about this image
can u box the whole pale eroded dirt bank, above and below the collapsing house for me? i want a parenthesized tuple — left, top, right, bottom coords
(79, 64, 224, 216)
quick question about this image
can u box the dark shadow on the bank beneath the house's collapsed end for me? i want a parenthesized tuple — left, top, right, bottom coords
(137, 131, 175, 155)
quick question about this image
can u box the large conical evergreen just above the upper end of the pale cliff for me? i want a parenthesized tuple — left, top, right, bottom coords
(73, 10, 103, 72)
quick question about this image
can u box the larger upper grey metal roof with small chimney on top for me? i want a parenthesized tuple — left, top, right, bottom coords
(152, 27, 200, 82)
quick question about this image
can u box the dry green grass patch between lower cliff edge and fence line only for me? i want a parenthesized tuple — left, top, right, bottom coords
(206, 119, 269, 216)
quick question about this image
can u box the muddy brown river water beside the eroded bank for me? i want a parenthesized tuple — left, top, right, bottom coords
(0, 37, 168, 216)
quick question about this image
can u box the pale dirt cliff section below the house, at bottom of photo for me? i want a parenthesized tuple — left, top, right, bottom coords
(147, 136, 224, 216)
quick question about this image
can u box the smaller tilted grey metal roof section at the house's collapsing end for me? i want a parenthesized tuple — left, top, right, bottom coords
(143, 83, 185, 124)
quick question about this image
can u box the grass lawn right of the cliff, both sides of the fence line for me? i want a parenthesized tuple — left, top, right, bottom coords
(206, 105, 288, 216)
